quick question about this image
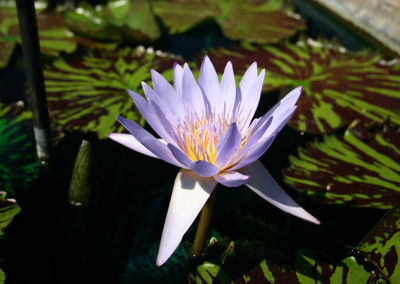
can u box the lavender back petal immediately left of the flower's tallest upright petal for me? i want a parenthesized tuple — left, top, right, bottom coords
(182, 63, 204, 117)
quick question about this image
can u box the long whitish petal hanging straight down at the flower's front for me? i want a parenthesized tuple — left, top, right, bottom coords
(156, 170, 217, 266)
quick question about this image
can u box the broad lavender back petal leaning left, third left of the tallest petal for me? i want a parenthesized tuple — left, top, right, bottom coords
(151, 70, 184, 114)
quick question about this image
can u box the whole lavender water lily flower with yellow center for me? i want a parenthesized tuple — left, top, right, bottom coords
(109, 56, 319, 265)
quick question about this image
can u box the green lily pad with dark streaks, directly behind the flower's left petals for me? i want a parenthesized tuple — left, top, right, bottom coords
(44, 47, 177, 138)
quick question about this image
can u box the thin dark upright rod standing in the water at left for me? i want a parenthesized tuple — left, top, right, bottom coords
(16, 0, 53, 164)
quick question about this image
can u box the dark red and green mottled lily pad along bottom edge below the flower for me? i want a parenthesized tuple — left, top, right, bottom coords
(189, 245, 376, 284)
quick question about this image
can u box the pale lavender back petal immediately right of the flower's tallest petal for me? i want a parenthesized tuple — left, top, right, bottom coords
(217, 62, 236, 113)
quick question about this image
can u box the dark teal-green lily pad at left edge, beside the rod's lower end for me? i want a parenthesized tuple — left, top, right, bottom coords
(0, 103, 39, 196)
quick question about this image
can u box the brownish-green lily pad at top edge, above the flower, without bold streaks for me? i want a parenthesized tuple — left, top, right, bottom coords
(152, 0, 305, 43)
